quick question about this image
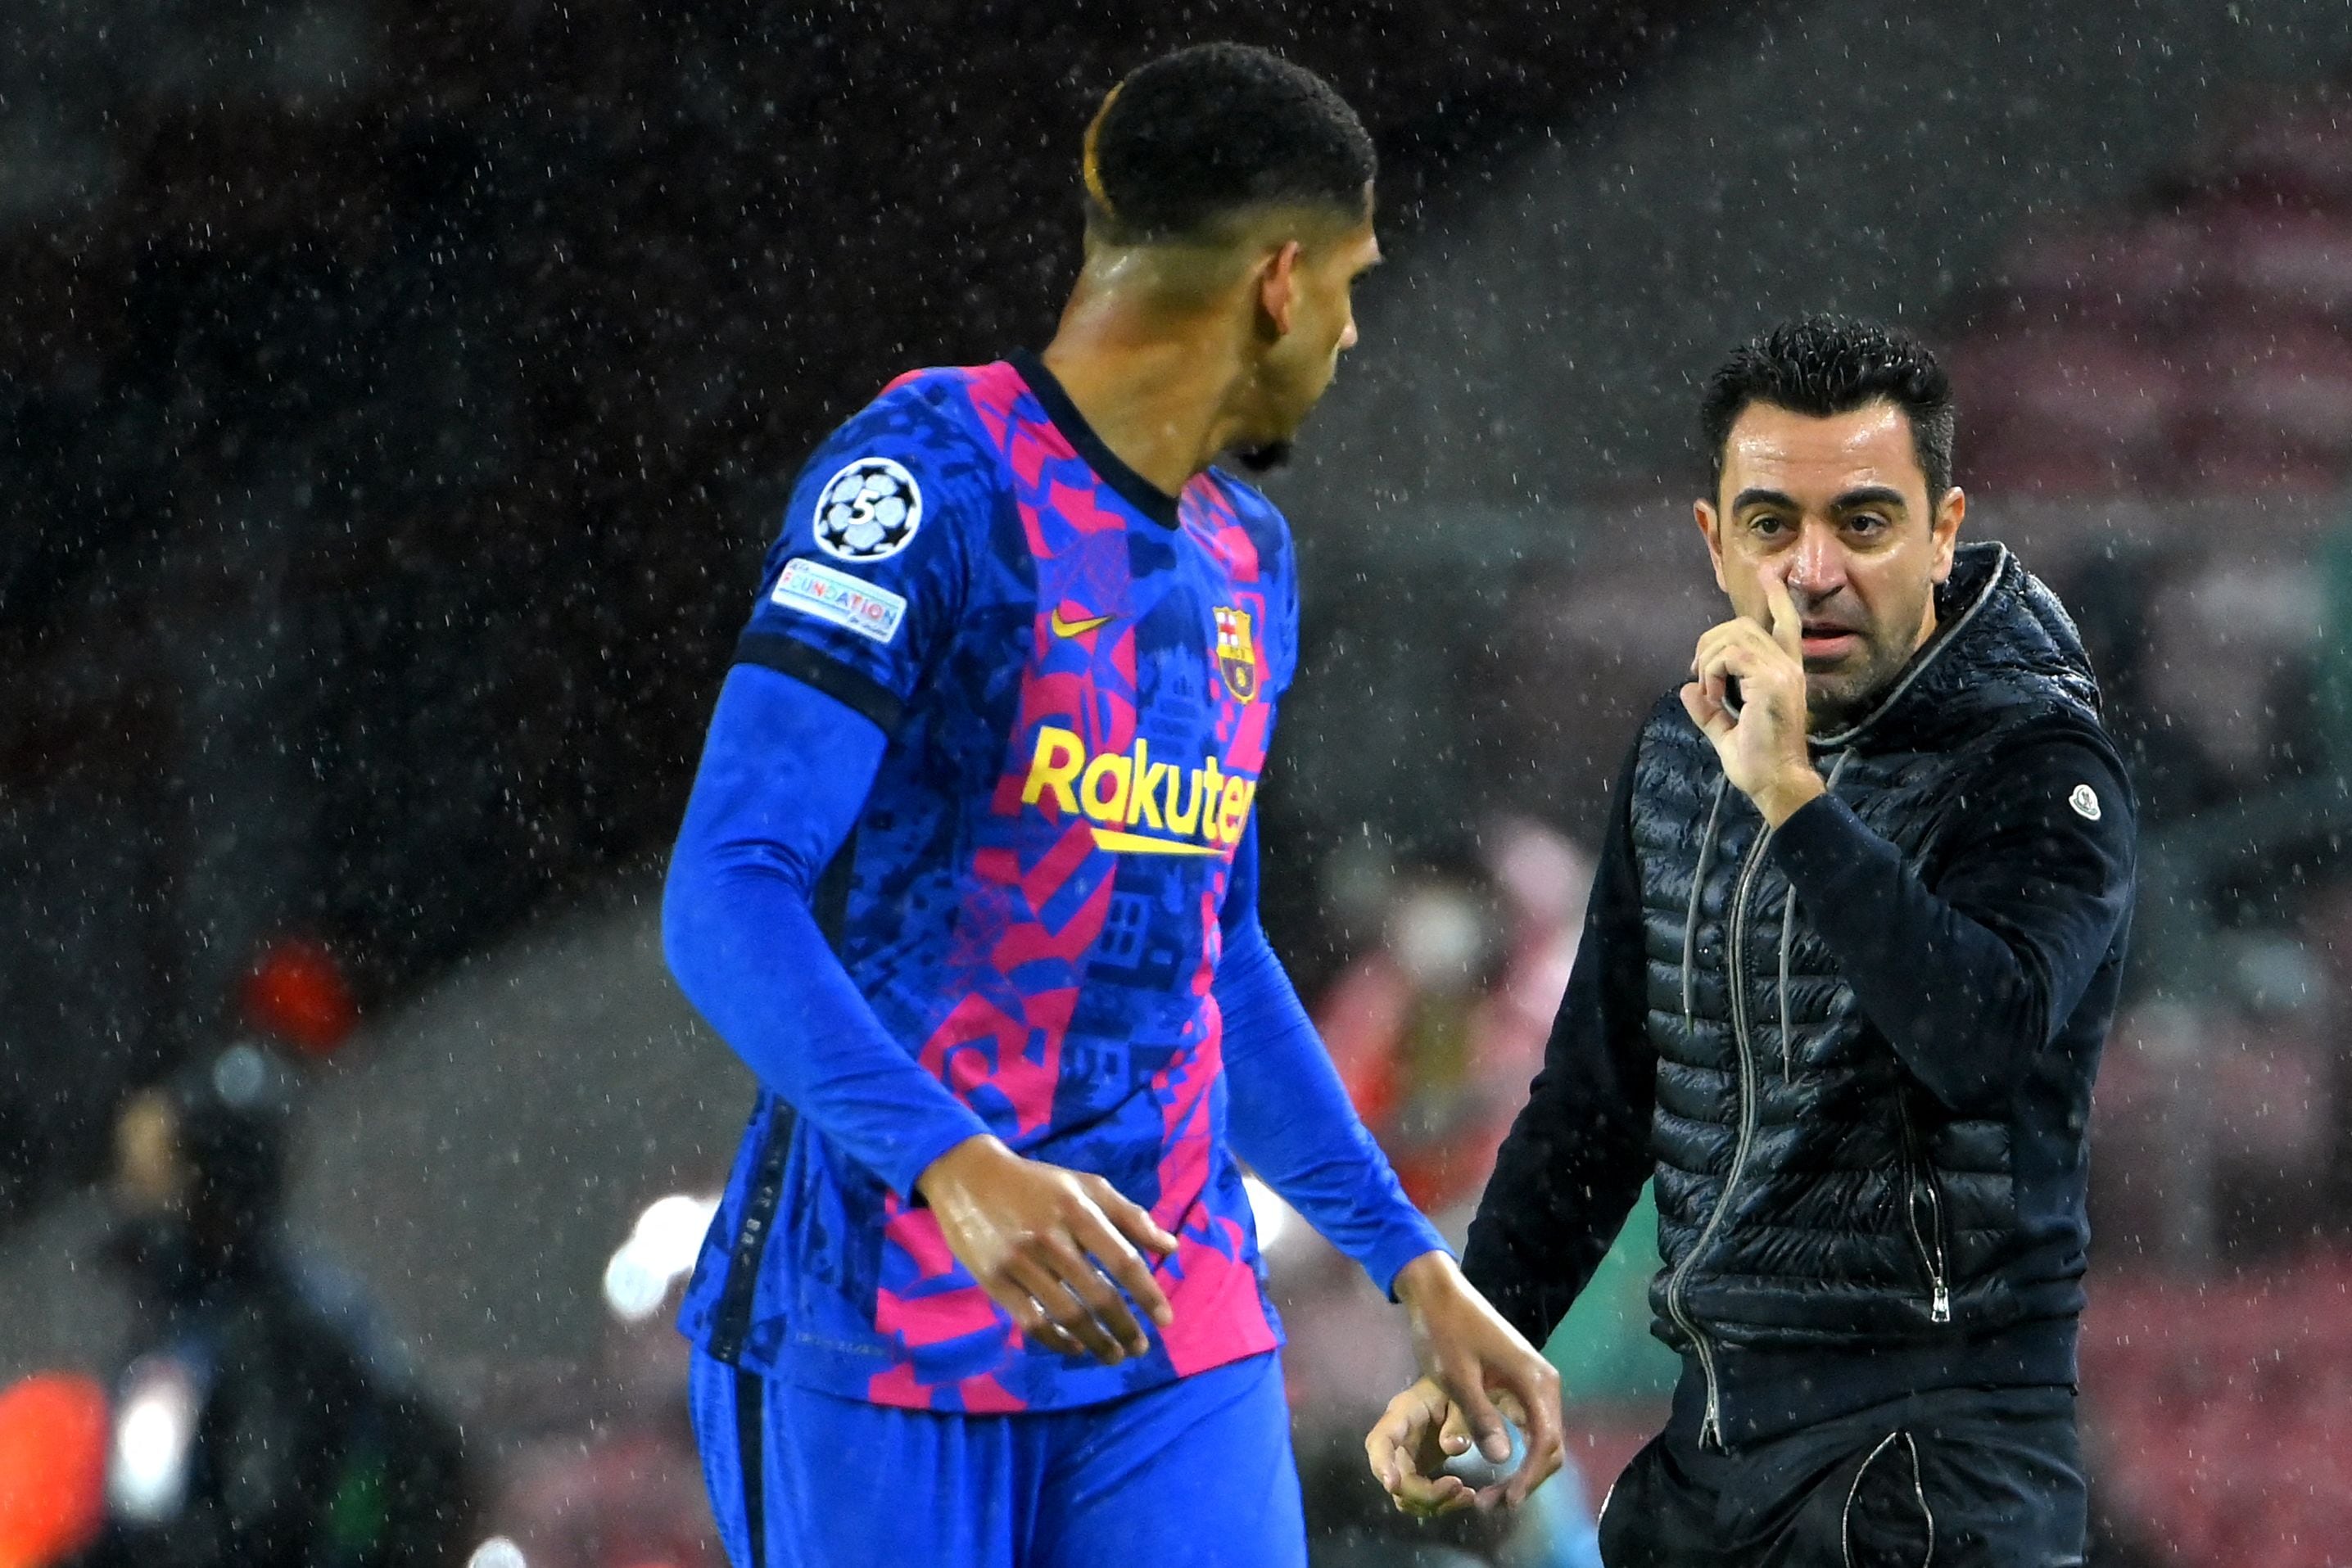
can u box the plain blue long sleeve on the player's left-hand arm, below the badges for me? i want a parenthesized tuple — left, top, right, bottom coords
(661, 663, 988, 1196)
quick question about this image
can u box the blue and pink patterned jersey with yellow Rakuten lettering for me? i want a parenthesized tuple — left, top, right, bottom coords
(682, 359, 1298, 1411)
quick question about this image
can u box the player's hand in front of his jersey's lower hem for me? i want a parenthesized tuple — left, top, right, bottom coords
(915, 1138, 1176, 1366)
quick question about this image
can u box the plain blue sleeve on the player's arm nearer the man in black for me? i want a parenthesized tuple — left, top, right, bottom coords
(1216, 820, 1446, 1293)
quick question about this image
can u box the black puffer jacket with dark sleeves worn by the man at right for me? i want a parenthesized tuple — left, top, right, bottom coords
(1465, 545, 2133, 1444)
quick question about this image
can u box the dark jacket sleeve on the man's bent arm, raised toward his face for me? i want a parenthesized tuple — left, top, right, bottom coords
(1773, 729, 2136, 1112)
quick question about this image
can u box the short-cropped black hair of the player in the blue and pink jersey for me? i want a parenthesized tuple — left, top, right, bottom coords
(1084, 45, 1378, 245)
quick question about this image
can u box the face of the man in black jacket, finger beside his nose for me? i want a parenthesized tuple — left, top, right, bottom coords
(1696, 402, 1966, 731)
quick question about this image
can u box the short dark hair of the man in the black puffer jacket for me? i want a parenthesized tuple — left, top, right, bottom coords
(1698, 315, 1952, 505)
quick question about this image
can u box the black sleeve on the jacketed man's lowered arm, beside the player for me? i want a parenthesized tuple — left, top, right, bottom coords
(1463, 757, 1658, 1344)
